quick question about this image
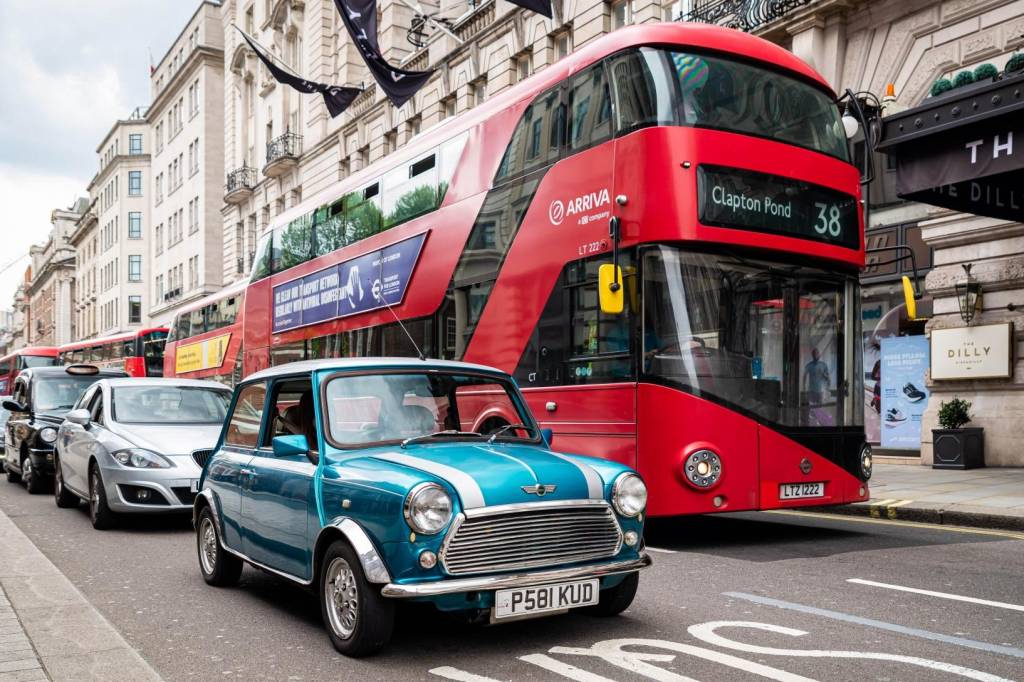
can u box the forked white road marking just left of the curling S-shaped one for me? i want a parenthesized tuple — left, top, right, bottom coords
(550, 639, 815, 682)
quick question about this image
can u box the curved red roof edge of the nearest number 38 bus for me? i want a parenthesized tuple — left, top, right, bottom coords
(270, 22, 836, 233)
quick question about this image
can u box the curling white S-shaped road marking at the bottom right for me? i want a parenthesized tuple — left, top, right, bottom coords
(688, 621, 1011, 682)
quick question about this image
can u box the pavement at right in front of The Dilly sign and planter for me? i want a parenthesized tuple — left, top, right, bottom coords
(806, 462, 1024, 530)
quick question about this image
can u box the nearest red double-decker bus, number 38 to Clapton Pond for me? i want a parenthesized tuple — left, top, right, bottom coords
(235, 24, 870, 515)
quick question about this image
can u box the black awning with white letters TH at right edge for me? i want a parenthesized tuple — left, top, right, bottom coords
(878, 73, 1024, 221)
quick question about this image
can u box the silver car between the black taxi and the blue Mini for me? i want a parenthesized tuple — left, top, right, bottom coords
(53, 379, 231, 529)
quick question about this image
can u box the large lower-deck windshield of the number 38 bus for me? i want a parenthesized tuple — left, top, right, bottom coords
(642, 246, 863, 427)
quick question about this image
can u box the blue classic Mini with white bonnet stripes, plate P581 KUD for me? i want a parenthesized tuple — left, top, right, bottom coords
(194, 358, 650, 656)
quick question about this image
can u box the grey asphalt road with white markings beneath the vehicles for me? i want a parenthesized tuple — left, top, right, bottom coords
(0, 483, 1024, 682)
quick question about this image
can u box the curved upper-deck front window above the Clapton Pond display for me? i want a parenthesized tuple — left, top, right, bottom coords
(609, 48, 850, 161)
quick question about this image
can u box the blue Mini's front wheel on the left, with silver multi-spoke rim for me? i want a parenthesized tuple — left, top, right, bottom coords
(319, 540, 394, 657)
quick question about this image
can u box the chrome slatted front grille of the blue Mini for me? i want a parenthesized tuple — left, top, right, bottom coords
(441, 503, 622, 576)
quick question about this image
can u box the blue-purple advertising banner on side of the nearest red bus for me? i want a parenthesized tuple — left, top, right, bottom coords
(273, 233, 427, 334)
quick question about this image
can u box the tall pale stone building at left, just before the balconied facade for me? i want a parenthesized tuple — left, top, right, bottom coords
(143, 0, 224, 326)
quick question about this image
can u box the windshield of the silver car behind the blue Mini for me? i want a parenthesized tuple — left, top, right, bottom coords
(112, 386, 231, 424)
